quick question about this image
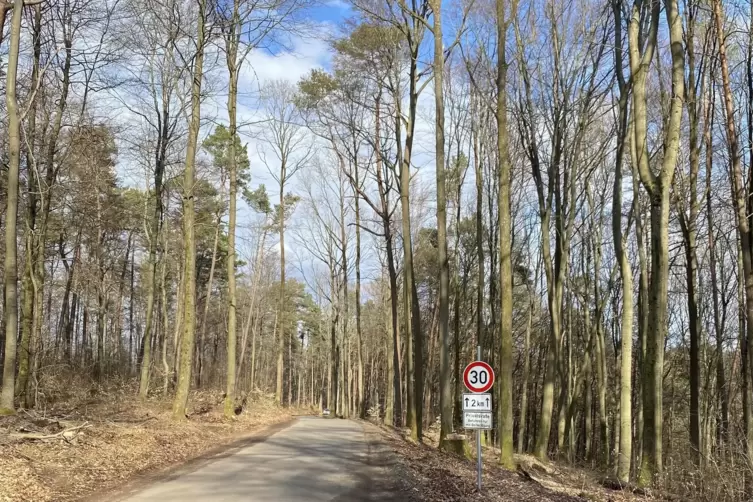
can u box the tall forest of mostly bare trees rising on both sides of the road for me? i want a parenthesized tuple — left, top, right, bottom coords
(0, 0, 753, 500)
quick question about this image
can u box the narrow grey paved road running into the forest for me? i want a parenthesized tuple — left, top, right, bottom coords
(119, 417, 406, 502)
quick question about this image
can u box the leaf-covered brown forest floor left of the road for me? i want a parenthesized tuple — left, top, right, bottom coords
(0, 385, 294, 502)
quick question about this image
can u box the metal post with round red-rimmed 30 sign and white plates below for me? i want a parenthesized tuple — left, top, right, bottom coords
(463, 345, 494, 492)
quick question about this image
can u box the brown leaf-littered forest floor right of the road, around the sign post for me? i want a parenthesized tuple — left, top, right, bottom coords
(374, 427, 654, 502)
